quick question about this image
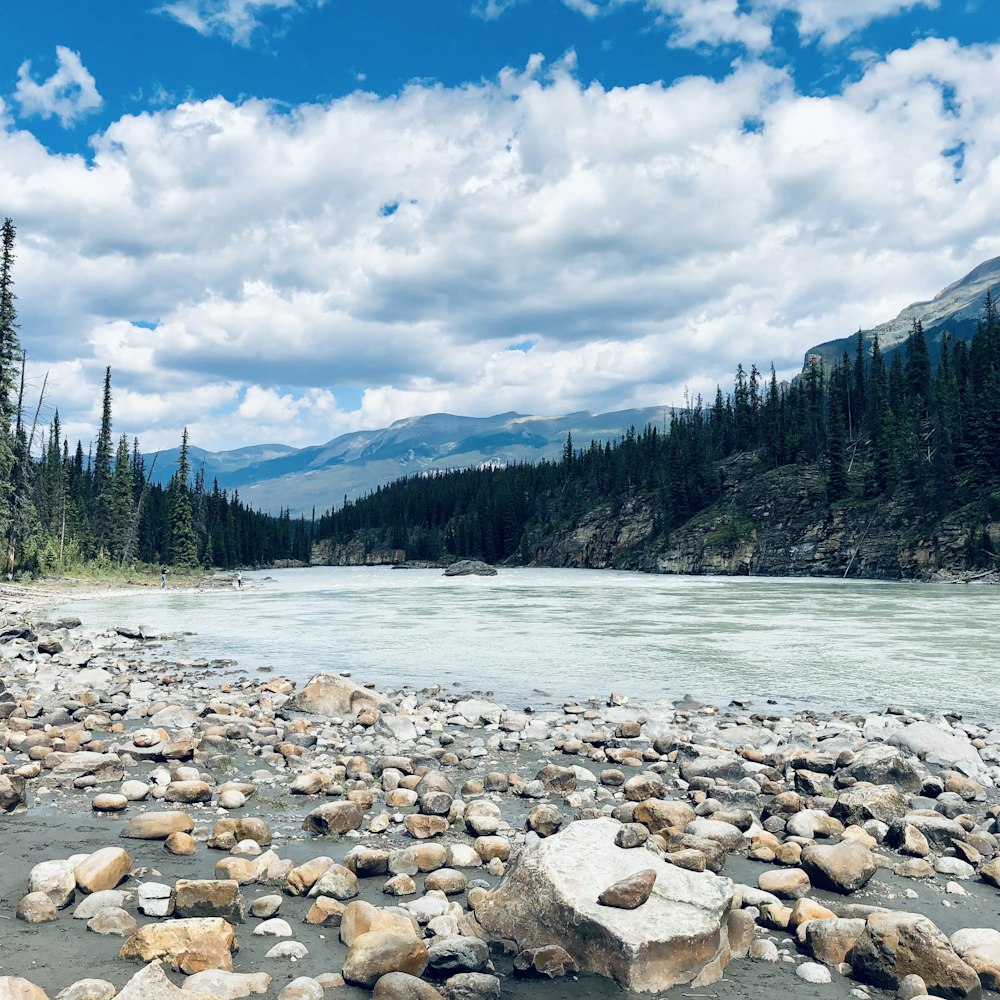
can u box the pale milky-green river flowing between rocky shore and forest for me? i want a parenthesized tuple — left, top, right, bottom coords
(52, 567, 1000, 723)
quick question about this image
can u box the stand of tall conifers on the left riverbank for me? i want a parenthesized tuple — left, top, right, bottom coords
(0, 218, 313, 578)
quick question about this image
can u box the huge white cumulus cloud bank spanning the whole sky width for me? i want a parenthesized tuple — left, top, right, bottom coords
(0, 40, 1000, 448)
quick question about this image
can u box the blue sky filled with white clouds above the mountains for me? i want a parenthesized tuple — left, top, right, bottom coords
(0, 0, 1000, 450)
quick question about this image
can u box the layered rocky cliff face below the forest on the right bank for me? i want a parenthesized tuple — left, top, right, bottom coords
(530, 456, 1000, 580)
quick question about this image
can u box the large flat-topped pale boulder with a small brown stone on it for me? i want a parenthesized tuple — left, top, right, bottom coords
(468, 818, 733, 992)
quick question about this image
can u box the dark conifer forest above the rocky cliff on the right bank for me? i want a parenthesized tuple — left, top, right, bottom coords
(316, 294, 1000, 563)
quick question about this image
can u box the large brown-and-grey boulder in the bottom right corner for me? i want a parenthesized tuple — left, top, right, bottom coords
(847, 911, 980, 998)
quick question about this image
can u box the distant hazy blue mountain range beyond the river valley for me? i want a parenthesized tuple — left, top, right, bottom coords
(154, 406, 670, 516)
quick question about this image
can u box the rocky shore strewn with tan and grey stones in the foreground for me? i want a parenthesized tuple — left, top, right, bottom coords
(0, 589, 1000, 1000)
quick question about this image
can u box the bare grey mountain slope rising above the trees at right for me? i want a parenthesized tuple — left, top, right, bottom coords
(805, 257, 1000, 368)
